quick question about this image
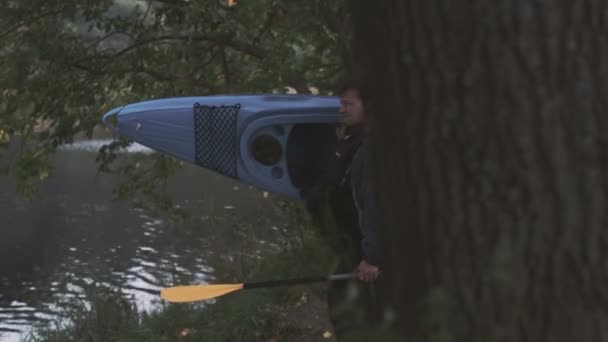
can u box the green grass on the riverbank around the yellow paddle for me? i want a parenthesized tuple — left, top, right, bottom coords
(27, 200, 334, 342)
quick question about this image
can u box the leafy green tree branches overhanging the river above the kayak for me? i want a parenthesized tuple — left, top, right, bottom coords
(0, 0, 347, 209)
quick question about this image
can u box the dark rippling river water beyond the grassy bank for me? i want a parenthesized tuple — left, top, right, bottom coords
(0, 140, 282, 342)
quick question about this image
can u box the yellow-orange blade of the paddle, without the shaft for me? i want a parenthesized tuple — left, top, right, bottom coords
(160, 284, 243, 303)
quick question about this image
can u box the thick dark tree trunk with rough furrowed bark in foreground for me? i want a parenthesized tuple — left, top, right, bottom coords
(350, 0, 608, 341)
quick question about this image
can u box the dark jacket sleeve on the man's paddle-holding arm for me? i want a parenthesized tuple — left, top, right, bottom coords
(350, 139, 381, 266)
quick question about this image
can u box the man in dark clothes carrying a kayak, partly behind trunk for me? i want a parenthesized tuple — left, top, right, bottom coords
(307, 81, 381, 337)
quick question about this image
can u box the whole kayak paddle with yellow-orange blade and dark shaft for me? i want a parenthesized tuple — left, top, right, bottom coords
(160, 273, 357, 303)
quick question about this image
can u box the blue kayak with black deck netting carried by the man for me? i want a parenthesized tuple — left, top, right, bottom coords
(103, 94, 340, 199)
